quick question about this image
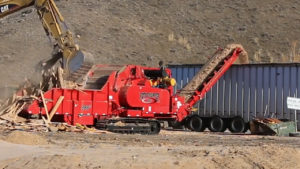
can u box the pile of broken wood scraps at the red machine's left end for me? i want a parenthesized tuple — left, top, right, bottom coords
(0, 67, 103, 133)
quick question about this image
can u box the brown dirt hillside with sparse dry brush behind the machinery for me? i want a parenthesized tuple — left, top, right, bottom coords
(0, 0, 300, 93)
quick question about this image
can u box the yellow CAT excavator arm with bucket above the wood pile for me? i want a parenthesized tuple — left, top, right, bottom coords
(0, 0, 93, 81)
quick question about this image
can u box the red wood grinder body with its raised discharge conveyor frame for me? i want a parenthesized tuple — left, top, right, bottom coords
(26, 46, 241, 125)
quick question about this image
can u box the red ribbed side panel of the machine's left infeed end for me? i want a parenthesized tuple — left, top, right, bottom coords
(27, 89, 111, 125)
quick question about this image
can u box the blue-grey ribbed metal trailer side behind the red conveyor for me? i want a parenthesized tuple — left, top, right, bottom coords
(168, 63, 300, 128)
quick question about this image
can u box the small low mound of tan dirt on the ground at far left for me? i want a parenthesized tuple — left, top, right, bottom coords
(0, 131, 48, 145)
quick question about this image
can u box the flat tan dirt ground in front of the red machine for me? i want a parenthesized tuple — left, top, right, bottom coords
(0, 130, 300, 169)
